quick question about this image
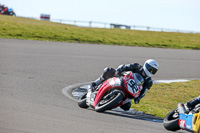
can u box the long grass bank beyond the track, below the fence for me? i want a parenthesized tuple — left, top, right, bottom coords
(0, 15, 200, 49)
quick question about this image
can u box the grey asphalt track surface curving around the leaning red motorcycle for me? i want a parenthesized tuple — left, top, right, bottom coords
(0, 39, 200, 133)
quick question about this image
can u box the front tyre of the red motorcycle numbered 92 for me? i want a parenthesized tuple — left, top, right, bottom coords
(95, 93, 124, 112)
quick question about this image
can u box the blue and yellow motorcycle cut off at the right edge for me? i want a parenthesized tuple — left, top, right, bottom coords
(163, 103, 200, 133)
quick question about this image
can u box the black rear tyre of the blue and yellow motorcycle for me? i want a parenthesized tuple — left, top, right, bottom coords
(163, 109, 180, 131)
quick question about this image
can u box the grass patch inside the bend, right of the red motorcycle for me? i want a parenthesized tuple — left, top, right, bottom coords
(132, 80, 200, 117)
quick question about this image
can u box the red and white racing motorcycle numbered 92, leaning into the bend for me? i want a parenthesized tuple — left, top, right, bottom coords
(78, 72, 144, 112)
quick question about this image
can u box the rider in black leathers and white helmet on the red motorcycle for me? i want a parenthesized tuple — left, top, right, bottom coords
(91, 59, 159, 110)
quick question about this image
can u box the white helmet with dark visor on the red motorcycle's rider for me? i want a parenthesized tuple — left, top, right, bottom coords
(143, 59, 159, 77)
